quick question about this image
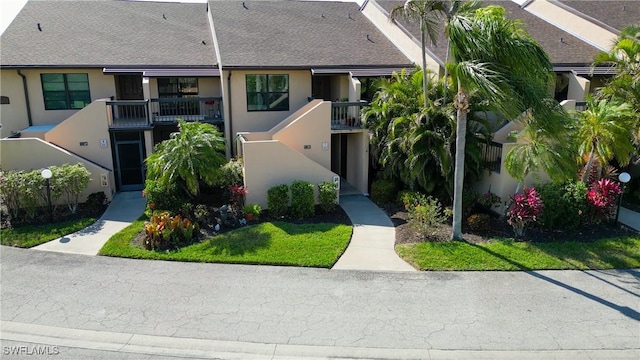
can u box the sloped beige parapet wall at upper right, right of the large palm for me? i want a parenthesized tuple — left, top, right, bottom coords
(524, 0, 616, 51)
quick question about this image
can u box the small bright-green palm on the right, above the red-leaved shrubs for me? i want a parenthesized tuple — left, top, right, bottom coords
(575, 97, 637, 182)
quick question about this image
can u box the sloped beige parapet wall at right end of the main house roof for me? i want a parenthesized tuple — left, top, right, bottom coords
(362, 1, 444, 74)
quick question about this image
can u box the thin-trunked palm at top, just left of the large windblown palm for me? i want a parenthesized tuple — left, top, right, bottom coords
(389, 0, 444, 108)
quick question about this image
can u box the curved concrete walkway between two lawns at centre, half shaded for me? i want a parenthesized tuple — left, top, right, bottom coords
(333, 195, 416, 271)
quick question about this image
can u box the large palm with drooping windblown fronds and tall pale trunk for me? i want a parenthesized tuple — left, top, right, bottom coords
(447, 6, 562, 240)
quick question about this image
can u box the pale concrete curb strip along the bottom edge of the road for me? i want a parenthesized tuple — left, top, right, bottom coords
(0, 321, 640, 360)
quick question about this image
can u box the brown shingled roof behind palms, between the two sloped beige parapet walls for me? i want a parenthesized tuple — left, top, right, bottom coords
(377, 0, 599, 65)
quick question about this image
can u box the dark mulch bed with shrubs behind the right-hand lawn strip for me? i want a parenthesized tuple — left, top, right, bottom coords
(381, 204, 640, 244)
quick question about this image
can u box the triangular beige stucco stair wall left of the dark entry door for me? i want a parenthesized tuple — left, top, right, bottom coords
(44, 99, 114, 169)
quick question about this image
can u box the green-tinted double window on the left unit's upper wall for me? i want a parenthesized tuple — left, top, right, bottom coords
(40, 74, 91, 110)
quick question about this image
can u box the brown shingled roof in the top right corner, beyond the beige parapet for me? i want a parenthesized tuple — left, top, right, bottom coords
(558, 0, 640, 30)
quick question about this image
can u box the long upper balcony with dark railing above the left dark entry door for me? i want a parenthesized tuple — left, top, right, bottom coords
(106, 97, 224, 128)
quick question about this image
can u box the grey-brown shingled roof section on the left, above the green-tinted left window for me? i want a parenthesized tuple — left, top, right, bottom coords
(0, 1, 217, 68)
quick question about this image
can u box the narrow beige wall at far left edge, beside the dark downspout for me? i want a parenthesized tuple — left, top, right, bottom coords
(0, 69, 29, 138)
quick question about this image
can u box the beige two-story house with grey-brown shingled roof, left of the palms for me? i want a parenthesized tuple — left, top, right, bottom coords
(0, 1, 413, 205)
